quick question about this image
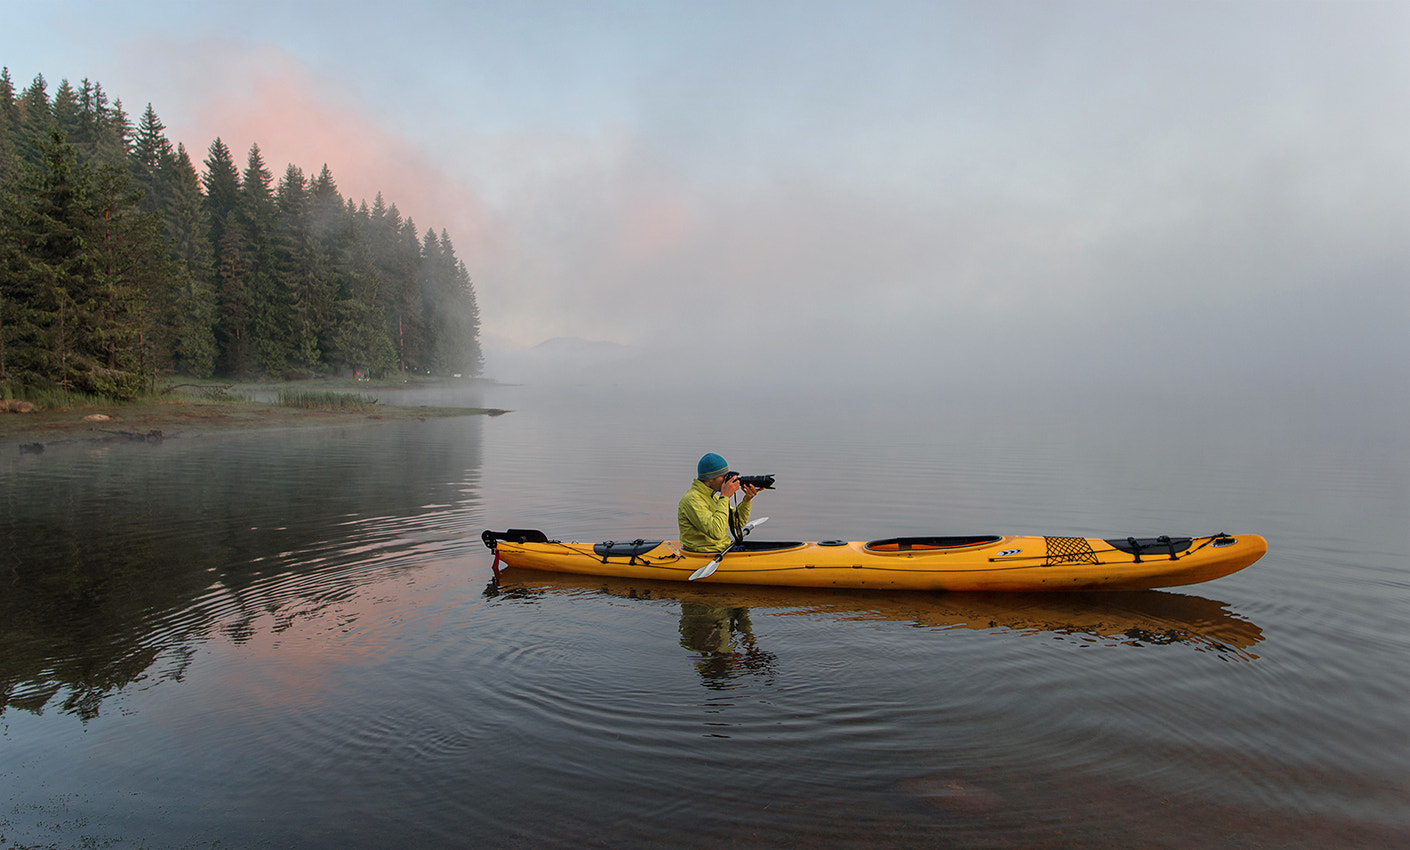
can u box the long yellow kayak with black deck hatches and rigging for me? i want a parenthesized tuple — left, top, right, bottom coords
(481, 529, 1268, 591)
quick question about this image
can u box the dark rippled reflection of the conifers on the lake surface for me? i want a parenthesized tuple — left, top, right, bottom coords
(0, 417, 481, 719)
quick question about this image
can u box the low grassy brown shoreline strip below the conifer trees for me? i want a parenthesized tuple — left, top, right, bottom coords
(0, 399, 508, 451)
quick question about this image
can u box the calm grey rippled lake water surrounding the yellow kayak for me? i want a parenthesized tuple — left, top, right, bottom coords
(0, 388, 1410, 849)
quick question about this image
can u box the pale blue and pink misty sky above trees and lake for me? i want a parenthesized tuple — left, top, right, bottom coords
(0, 0, 1410, 392)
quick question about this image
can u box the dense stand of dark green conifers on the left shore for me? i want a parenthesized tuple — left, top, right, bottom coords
(0, 68, 484, 398)
